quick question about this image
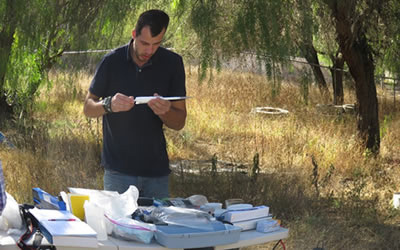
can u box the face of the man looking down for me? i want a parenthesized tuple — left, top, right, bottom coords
(132, 26, 165, 66)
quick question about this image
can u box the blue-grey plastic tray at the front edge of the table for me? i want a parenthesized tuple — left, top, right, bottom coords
(155, 224, 241, 248)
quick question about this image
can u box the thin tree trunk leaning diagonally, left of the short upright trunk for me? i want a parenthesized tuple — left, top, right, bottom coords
(301, 44, 328, 94)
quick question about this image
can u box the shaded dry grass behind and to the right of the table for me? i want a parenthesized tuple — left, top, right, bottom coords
(170, 161, 400, 249)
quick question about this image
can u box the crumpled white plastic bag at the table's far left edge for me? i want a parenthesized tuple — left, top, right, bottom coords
(0, 192, 24, 231)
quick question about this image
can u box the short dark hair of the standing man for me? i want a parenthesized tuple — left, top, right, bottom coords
(135, 10, 169, 37)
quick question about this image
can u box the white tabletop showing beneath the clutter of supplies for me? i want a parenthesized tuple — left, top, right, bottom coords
(0, 228, 289, 250)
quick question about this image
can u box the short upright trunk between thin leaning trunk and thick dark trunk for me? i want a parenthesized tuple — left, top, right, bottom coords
(331, 53, 344, 105)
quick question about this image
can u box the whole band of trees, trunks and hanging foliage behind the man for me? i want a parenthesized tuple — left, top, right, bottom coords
(0, 0, 400, 153)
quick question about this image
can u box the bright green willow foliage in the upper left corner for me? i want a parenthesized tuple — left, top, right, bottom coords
(0, 0, 135, 121)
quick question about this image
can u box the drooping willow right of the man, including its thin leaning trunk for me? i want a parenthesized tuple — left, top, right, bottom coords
(179, 0, 334, 93)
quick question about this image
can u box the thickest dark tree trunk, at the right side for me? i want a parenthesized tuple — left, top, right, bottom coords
(329, 1, 380, 154)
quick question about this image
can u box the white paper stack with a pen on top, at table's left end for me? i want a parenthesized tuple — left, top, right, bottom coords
(29, 208, 98, 248)
